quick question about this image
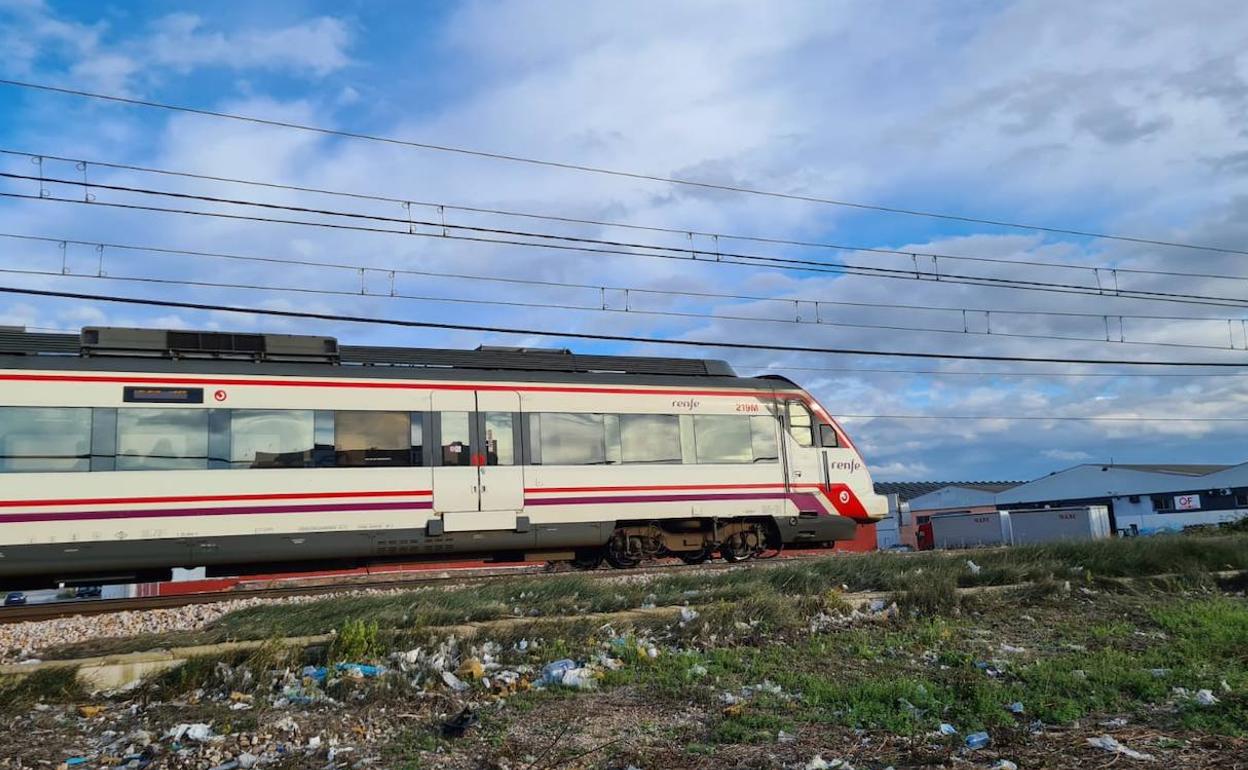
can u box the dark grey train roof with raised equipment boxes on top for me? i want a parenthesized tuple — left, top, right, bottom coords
(0, 327, 796, 389)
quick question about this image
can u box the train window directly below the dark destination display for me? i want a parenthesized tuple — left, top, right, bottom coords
(117, 408, 208, 470)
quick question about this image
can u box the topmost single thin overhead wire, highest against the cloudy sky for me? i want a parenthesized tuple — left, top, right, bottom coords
(0, 79, 1248, 256)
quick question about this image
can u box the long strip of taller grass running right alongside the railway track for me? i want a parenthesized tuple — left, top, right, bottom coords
(47, 534, 1248, 658)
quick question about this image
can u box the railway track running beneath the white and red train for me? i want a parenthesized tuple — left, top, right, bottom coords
(0, 550, 831, 625)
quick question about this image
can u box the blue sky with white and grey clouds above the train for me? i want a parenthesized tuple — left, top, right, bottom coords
(0, 0, 1248, 480)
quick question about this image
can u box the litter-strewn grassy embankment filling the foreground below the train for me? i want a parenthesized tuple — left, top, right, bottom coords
(0, 535, 1248, 769)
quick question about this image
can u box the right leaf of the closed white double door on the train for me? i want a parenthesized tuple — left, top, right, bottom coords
(477, 391, 524, 516)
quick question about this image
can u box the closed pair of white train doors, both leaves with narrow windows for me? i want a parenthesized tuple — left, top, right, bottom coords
(433, 391, 524, 532)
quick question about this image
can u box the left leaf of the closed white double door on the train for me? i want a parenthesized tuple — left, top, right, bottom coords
(432, 391, 480, 521)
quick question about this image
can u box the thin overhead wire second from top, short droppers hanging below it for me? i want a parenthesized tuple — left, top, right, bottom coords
(9, 149, 1248, 282)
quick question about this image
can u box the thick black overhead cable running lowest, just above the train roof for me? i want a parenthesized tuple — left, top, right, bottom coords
(0, 286, 1248, 371)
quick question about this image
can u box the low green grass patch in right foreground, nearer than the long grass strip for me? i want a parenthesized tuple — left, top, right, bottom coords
(594, 586, 1248, 743)
